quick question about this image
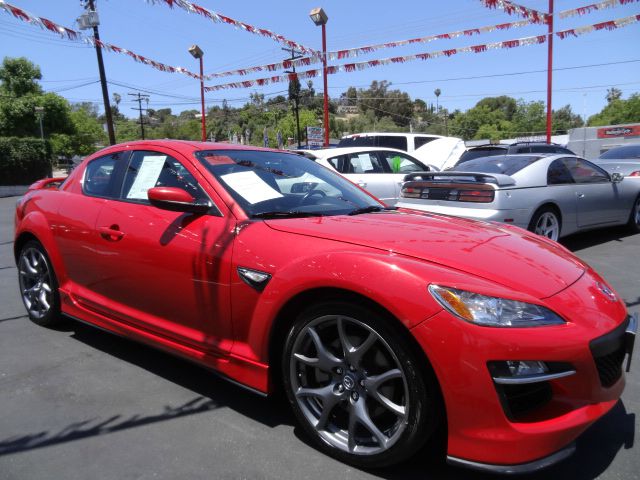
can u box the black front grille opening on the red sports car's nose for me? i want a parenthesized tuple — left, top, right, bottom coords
(589, 318, 629, 388)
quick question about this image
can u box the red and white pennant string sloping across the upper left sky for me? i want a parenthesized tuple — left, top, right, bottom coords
(0, 0, 200, 79)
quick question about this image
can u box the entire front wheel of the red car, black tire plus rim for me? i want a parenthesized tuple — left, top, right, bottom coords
(282, 301, 444, 468)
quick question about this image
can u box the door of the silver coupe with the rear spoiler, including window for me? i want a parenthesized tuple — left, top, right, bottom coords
(564, 158, 623, 228)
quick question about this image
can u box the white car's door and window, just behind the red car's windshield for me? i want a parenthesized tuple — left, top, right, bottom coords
(327, 151, 397, 205)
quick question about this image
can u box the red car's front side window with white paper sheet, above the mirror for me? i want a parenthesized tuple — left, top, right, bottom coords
(121, 151, 208, 203)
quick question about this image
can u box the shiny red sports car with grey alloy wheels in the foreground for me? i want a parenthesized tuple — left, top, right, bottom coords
(15, 141, 637, 472)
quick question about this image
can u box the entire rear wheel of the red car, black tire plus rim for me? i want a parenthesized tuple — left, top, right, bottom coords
(18, 240, 63, 327)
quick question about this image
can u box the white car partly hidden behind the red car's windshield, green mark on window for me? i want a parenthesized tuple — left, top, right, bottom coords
(299, 147, 433, 205)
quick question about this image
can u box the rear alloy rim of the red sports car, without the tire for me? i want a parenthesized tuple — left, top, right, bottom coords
(18, 247, 54, 319)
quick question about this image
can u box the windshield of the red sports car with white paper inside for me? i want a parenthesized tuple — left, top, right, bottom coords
(195, 150, 383, 218)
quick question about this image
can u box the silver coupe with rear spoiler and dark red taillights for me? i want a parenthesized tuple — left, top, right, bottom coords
(397, 155, 640, 240)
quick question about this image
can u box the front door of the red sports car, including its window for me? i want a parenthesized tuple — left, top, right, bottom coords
(87, 148, 235, 351)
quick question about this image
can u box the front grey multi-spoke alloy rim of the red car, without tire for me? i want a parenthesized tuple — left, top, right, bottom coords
(289, 315, 410, 455)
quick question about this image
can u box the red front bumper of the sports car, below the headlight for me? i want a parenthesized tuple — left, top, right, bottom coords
(412, 272, 637, 466)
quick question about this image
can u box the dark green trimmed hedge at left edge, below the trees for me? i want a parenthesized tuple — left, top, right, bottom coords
(0, 137, 51, 185)
